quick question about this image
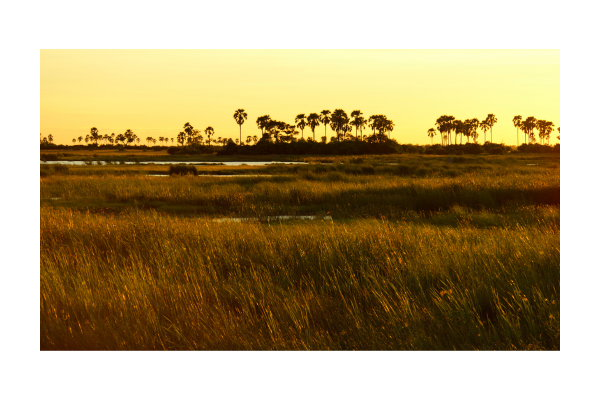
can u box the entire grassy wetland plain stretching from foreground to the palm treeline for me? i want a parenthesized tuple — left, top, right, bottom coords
(40, 152, 560, 350)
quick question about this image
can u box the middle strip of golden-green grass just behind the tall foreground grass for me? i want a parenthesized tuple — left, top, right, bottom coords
(40, 169, 560, 219)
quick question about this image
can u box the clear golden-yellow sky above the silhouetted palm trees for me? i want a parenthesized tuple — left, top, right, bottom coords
(40, 50, 560, 145)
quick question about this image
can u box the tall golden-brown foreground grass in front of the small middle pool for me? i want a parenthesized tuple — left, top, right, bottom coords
(40, 207, 560, 350)
